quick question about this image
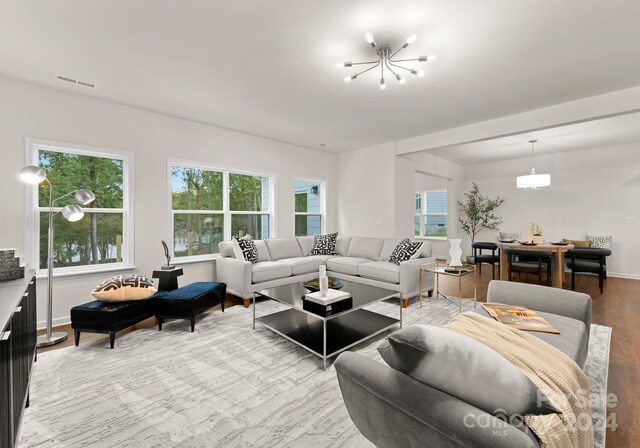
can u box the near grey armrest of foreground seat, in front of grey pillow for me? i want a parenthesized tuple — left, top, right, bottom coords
(335, 352, 538, 448)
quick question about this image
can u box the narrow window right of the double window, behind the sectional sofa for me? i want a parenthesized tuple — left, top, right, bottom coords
(294, 179, 324, 236)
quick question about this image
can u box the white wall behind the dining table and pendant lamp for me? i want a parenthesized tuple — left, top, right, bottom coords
(459, 143, 640, 278)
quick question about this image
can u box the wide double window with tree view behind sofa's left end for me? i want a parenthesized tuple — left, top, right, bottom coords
(169, 161, 272, 260)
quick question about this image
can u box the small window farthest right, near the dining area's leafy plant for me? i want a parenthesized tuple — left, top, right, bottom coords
(415, 191, 447, 238)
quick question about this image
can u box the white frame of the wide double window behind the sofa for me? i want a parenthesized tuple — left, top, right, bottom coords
(166, 157, 276, 264)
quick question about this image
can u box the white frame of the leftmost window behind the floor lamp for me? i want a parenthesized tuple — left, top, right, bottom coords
(25, 137, 135, 278)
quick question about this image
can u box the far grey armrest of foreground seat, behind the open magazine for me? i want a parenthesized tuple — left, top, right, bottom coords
(487, 280, 591, 332)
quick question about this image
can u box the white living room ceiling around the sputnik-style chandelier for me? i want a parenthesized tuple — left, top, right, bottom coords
(0, 0, 640, 151)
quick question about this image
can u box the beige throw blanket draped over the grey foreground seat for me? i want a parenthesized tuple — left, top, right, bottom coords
(443, 312, 593, 448)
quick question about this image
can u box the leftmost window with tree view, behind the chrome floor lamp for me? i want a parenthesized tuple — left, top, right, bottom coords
(27, 140, 133, 273)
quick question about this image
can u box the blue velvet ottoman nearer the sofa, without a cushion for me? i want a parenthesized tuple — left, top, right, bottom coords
(151, 282, 227, 333)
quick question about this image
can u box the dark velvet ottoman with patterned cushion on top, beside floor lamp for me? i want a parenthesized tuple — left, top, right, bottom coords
(71, 296, 153, 348)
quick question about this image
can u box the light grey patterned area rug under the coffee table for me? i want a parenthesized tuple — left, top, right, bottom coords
(19, 299, 611, 448)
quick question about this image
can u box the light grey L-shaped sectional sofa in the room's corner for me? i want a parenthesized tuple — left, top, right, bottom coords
(216, 236, 435, 308)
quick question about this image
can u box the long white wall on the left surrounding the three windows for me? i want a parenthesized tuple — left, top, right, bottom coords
(0, 78, 337, 324)
